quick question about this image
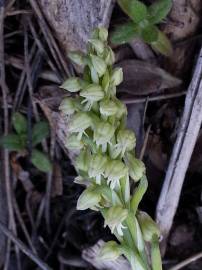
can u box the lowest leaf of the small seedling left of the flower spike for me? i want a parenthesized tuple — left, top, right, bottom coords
(31, 149, 52, 172)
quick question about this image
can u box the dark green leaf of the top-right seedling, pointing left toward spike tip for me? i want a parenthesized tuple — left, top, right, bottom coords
(111, 22, 138, 44)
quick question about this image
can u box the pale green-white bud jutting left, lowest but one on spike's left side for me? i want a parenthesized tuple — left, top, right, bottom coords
(77, 187, 101, 210)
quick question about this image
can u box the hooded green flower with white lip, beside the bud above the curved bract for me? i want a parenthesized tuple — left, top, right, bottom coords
(104, 160, 128, 189)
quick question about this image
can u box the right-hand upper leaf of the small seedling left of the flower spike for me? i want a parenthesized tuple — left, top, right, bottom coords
(32, 121, 49, 146)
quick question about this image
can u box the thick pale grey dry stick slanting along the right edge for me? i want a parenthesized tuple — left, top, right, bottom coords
(156, 46, 202, 251)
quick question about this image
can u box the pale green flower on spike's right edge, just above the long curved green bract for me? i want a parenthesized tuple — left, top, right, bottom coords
(125, 153, 146, 181)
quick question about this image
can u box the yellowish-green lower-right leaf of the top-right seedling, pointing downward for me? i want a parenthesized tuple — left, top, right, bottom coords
(151, 31, 173, 56)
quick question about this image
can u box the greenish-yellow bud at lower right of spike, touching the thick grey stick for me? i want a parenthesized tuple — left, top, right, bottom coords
(137, 211, 160, 242)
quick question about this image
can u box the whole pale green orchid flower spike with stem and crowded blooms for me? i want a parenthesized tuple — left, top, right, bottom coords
(59, 28, 162, 270)
